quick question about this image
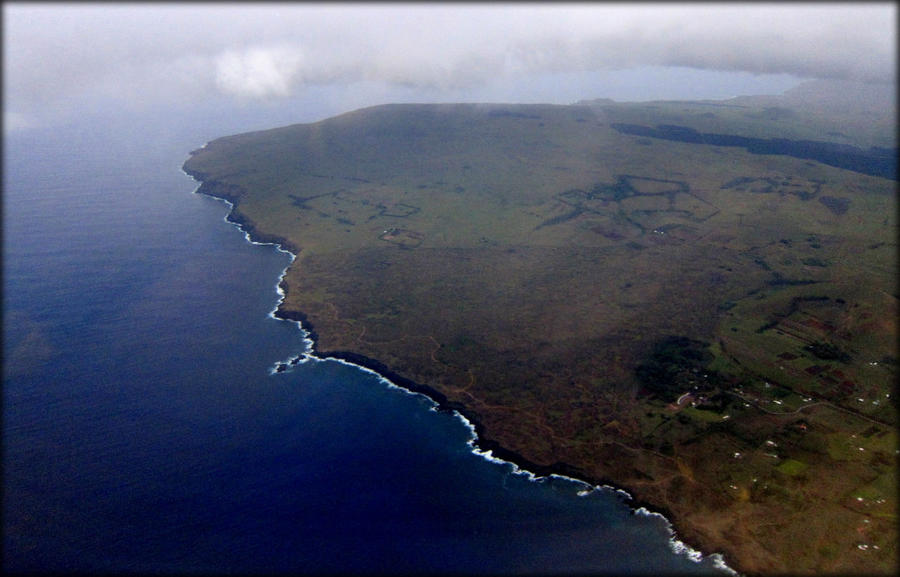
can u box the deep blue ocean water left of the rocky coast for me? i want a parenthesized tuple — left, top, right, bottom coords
(3, 106, 732, 574)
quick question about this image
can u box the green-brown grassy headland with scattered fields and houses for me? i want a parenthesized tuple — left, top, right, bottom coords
(184, 86, 898, 574)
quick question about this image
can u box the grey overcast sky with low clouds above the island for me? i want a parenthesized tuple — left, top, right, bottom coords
(3, 2, 897, 130)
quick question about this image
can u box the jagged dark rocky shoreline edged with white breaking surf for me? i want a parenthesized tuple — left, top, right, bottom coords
(181, 164, 742, 575)
